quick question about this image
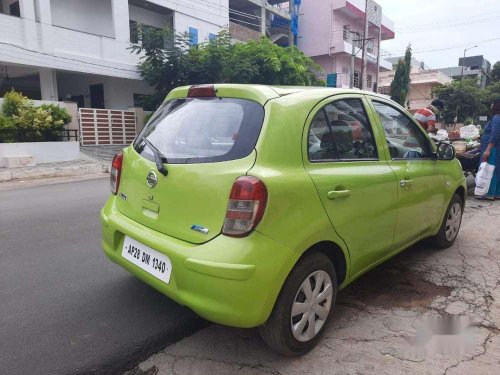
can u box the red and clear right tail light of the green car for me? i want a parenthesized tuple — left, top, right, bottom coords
(222, 176, 267, 237)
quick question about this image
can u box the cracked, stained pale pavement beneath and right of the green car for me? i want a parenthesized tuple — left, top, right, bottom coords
(127, 198, 500, 375)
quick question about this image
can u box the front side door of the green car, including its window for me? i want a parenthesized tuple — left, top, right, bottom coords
(371, 98, 445, 249)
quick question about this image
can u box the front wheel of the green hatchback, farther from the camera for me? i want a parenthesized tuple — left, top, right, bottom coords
(428, 194, 464, 249)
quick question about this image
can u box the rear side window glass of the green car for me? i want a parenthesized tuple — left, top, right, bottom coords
(309, 99, 378, 161)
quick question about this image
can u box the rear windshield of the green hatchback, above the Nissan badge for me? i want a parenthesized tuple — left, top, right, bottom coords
(134, 98, 264, 164)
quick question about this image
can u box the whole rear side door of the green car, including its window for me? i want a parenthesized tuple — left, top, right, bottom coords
(304, 95, 397, 276)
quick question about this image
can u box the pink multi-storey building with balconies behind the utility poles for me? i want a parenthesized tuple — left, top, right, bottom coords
(298, 0, 395, 89)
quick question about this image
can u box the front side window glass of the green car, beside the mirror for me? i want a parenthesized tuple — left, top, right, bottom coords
(373, 101, 432, 159)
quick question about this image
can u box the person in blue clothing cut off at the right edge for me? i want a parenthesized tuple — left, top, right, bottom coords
(478, 98, 500, 200)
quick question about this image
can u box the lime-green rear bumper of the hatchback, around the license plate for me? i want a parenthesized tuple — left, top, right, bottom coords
(100, 196, 297, 328)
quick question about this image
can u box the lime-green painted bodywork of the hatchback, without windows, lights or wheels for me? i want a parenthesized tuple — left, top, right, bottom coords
(101, 84, 465, 327)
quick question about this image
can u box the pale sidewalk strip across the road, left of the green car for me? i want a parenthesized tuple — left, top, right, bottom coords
(0, 159, 109, 183)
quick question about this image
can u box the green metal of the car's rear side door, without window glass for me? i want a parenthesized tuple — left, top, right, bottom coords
(302, 94, 398, 274)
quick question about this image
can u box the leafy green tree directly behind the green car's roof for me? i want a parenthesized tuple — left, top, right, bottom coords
(130, 28, 324, 105)
